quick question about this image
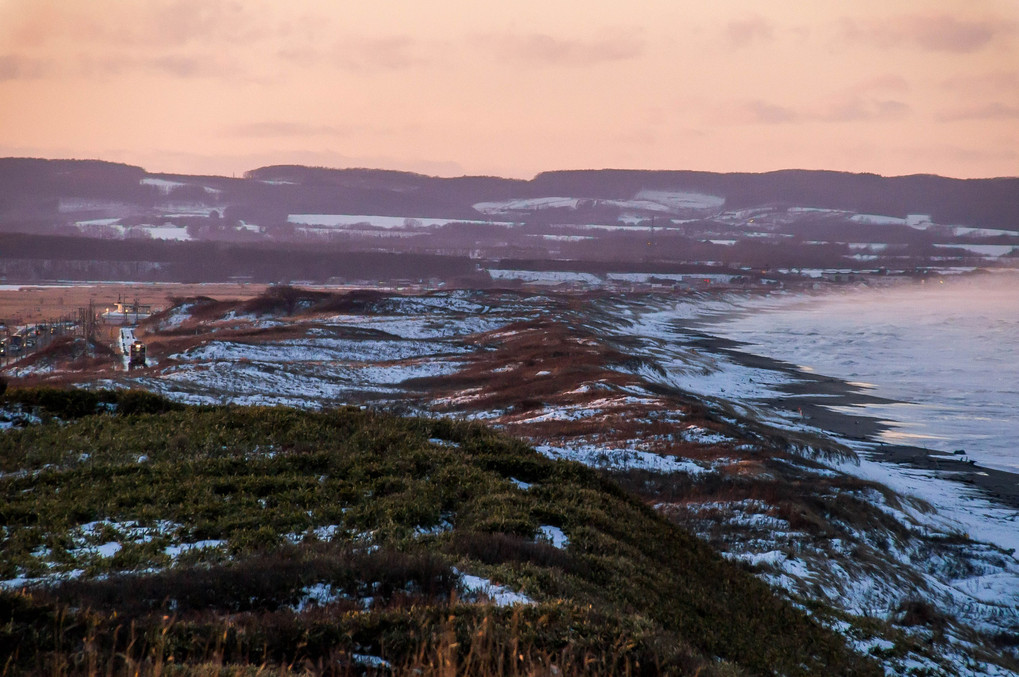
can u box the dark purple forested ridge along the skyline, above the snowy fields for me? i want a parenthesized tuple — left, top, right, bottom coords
(0, 158, 1019, 227)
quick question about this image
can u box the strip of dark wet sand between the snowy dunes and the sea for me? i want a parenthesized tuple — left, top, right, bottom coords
(682, 322, 1019, 510)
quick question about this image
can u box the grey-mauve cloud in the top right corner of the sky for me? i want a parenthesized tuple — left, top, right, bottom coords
(842, 14, 1015, 53)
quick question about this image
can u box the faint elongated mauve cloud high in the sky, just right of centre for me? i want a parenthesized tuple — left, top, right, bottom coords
(480, 32, 645, 66)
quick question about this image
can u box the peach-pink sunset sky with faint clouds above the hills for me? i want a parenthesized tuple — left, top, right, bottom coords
(0, 0, 1019, 178)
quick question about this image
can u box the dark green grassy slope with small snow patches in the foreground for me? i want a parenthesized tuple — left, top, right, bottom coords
(0, 392, 876, 675)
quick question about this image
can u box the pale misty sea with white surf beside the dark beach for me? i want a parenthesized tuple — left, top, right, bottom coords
(707, 274, 1019, 472)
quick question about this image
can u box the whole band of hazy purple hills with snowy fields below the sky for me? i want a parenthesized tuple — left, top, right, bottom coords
(0, 158, 1019, 282)
